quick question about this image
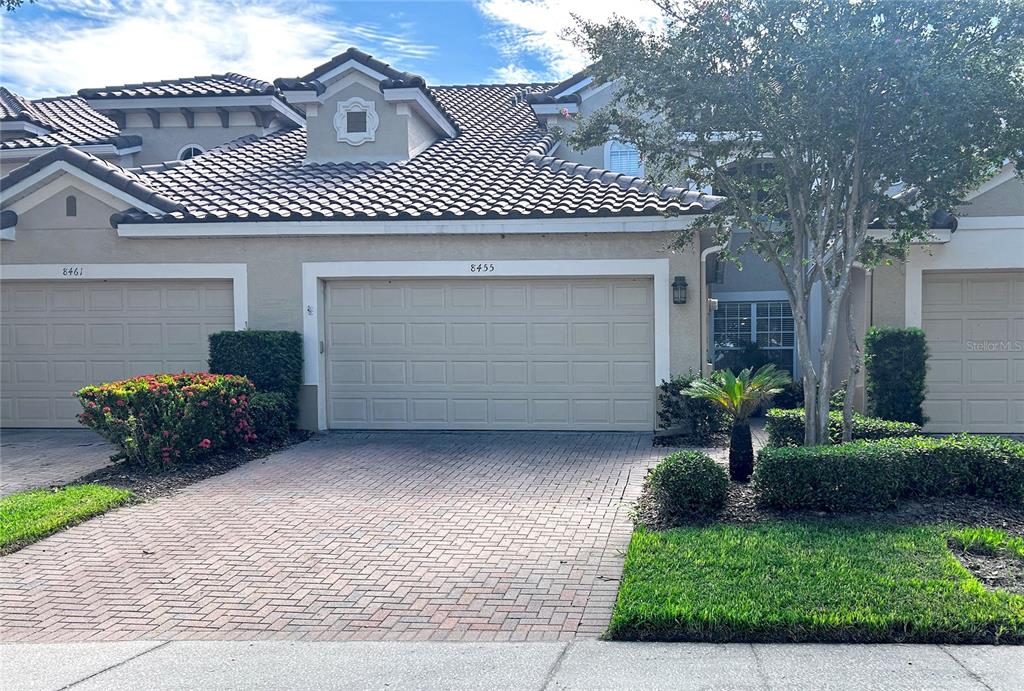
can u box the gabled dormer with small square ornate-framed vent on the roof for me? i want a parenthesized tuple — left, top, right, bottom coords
(274, 48, 458, 163)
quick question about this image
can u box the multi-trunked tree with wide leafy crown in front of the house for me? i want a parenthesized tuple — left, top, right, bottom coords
(570, 0, 1024, 444)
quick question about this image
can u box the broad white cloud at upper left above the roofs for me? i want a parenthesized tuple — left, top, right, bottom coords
(0, 0, 435, 97)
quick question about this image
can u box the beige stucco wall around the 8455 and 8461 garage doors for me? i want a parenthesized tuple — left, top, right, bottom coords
(0, 184, 700, 432)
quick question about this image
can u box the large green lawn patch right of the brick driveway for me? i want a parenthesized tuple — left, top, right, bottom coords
(607, 522, 1024, 643)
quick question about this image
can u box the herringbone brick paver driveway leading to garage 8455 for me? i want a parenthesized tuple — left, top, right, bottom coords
(0, 433, 656, 641)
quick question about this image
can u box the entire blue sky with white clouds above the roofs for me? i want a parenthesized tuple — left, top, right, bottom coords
(0, 0, 654, 97)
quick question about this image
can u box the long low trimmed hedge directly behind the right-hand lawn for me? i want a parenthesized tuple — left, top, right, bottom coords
(754, 434, 1024, 512)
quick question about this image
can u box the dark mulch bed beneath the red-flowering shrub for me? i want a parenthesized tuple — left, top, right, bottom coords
(69, 430, 310, 501)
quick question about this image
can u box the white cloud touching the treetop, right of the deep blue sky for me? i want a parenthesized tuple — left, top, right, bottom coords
(476, 0, 660, 80)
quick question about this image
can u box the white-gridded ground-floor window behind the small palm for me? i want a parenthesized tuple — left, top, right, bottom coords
(712, 300, 797, 375)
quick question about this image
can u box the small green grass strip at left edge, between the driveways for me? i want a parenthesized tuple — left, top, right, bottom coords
(0, 484, 134, 553)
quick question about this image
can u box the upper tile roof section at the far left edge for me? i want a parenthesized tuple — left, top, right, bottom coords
(0, 87, 136, 152)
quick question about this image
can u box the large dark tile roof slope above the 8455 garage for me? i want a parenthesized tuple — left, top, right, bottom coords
(108, 84, 720, 222)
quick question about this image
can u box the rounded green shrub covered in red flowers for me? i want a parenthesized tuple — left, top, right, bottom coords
(75, 372, 256, 465)
